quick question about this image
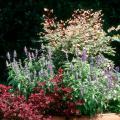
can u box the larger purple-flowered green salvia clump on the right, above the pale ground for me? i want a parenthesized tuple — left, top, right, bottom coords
(63, 51, 120, 115)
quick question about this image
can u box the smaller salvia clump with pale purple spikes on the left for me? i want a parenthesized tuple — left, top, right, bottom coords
(6, 46, 54, 97)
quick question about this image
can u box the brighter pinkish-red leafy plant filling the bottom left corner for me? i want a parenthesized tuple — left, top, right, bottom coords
(0, 84, 51, 120)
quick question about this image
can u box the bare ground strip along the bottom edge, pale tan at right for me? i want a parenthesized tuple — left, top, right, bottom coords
(52, 113, 120, 120)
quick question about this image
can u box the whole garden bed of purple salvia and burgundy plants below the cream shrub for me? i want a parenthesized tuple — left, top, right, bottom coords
(3, 39, 120, 120)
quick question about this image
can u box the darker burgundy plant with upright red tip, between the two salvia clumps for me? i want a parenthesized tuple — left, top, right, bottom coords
(29, 69, 84, 116)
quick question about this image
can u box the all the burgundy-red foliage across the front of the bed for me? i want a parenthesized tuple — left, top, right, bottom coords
(0, 69, 84, 120)
